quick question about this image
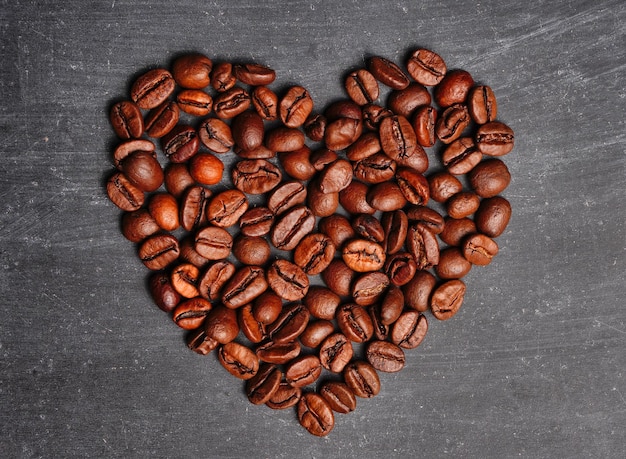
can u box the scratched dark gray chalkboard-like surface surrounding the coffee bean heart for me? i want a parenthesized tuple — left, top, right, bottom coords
(0, 0, 626, 458)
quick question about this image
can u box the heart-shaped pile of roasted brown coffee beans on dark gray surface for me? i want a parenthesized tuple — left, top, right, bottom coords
(107, 49, 514, 436)
